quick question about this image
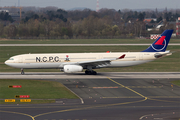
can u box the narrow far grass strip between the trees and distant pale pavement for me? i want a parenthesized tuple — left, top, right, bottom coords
(0, 39, 180, 44)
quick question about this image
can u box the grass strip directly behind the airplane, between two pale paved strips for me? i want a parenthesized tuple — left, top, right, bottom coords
(0, 46, 180, 72)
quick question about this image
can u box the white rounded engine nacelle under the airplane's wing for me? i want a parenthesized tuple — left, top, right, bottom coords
(64, 65, 83, 73)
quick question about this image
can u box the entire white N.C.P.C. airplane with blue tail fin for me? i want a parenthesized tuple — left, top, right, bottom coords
(5, 30, 173, 75)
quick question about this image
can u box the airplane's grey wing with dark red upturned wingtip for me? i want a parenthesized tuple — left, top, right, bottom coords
(76, 54, 126, 67)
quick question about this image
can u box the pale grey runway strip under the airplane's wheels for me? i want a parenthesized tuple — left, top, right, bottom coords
(0, 71, 180, 79)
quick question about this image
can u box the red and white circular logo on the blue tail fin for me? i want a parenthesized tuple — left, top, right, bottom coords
(151, 36, 166, 51)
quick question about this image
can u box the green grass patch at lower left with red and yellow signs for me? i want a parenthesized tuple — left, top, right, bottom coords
(0, 79, 78, 104)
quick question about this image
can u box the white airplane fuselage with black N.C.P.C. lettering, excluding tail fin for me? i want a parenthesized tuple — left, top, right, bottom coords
(5, 52, 163, 69)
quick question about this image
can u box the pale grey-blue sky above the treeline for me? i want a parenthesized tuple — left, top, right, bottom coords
(0, 0, 180, 10)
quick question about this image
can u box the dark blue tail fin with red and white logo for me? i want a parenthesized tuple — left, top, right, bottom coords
(142, 30, 173, 52)
